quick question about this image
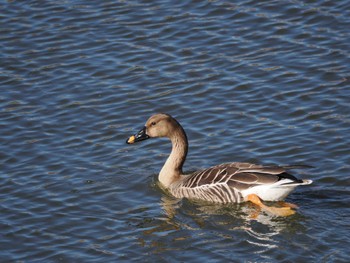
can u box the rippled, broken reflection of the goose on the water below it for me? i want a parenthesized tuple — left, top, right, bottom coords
(133, 187, 305, 260)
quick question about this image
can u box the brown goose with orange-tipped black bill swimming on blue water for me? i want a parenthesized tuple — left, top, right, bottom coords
(127, 113, 312, 216)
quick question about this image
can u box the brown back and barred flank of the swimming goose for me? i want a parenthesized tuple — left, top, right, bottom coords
(169, 162, 302, 203)
